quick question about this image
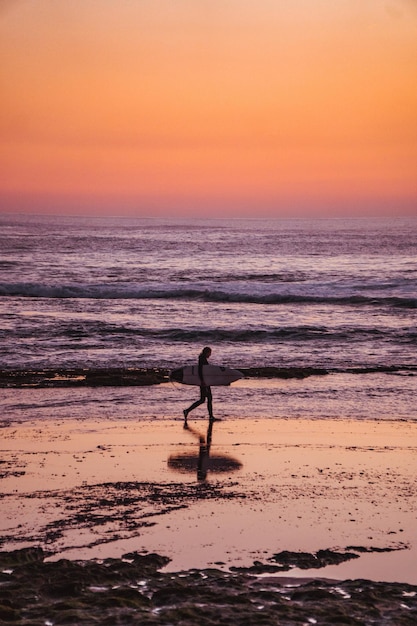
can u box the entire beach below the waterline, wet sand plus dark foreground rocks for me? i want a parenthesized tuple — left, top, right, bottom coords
(0, 418, 417, 624)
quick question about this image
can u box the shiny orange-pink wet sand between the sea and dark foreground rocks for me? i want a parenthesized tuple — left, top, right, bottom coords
(0, 418, 417, 584)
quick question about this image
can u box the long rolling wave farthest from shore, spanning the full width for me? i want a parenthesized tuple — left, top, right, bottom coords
(0, 283, 417, 309)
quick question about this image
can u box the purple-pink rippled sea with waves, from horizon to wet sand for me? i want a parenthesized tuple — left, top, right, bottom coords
(0, 215, 417, 419)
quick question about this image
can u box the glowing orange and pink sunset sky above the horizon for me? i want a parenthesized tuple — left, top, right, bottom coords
(0, 0, 417, 217)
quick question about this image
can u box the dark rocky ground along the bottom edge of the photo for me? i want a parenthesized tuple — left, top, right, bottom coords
(0, 548, 417, 626)
